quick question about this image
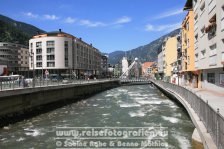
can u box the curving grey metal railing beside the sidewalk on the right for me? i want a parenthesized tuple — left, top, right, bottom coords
(151, 80, 224, 149)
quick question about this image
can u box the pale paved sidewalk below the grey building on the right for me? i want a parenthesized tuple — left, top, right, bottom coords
(184, 86, 224, 117)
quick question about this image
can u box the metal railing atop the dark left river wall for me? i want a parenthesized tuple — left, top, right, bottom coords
(0, 79, 118, 91)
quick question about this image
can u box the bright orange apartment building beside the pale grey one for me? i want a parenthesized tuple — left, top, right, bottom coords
(181, 10, 198, 87)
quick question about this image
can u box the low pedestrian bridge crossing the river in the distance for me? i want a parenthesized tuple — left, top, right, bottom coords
(120, 78, 151, 85)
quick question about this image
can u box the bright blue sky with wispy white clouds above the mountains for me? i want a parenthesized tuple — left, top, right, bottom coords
(0, 0, 187, 53)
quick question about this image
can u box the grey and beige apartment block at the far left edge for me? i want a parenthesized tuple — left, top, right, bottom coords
(0, 42, 29, 75)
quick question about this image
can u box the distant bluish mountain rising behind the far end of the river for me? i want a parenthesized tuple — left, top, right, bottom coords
(109, 29, 181, 65)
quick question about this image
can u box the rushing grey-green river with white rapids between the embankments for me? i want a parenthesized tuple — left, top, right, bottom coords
(0, 85, 194, 149)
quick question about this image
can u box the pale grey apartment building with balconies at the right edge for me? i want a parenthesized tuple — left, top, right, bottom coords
(185, 0, 224, 89)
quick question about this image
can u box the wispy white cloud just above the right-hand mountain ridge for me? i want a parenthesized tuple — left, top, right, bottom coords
(145, 22, 181, 32)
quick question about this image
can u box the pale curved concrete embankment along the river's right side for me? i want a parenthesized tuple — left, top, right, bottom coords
(152, 82, 217, 149)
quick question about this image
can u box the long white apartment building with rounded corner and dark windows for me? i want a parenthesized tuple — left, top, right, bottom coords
(29, 29, 101, 78)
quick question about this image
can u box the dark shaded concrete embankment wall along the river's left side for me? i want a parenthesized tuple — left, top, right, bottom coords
(0, 80, 120, 126)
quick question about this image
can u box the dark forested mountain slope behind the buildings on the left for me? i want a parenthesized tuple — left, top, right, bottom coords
(0, 15, 45, 37)
